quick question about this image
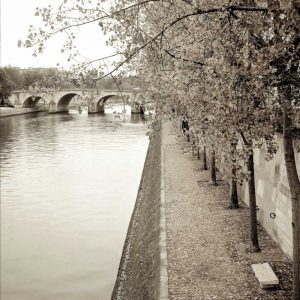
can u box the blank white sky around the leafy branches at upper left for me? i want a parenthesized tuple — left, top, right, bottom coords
(0, 0, 113, 68)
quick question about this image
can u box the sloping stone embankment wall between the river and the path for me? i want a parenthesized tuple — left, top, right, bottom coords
(111, 123, 161, 300)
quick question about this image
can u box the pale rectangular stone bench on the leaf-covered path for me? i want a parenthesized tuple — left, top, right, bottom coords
(251, 263, 279, 289)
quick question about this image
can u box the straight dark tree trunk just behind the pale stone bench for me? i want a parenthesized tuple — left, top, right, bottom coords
(247, 150, 260, 252)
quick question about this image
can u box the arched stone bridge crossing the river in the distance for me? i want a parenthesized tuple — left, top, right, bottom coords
(8, 89, 144, 113)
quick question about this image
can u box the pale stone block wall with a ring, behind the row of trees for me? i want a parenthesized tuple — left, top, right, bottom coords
(219, 137, 300, 257)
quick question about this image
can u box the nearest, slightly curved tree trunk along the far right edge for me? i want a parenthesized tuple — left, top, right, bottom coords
(283, 95, 300, 300)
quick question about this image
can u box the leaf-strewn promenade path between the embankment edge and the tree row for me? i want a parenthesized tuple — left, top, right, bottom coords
(162, 121, 292, 300)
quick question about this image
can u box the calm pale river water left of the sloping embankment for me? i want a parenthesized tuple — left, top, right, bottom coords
(0, 110, 148, 300)
